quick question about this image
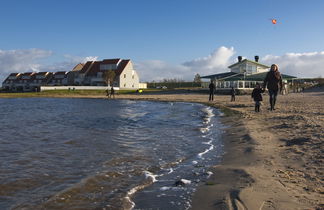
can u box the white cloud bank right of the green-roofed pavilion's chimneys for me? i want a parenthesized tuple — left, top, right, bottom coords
(262, 51, 324, 78)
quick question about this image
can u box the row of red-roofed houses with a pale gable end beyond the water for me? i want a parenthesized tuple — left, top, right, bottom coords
(2, 58, 140, 91)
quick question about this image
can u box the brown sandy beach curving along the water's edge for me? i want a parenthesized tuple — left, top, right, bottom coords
(1, 88, 324, 210)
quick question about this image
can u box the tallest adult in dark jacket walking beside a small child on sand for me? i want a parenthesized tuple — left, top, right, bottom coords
(263, 64, 282, 111)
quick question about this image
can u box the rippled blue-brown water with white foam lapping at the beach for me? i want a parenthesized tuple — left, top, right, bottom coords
(0, 98, 222, 209)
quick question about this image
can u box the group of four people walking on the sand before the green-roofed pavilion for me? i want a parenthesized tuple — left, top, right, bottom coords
(209, 64, 283, 112)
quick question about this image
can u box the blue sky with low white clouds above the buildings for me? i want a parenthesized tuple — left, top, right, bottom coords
(0, 0, 324, 81)
